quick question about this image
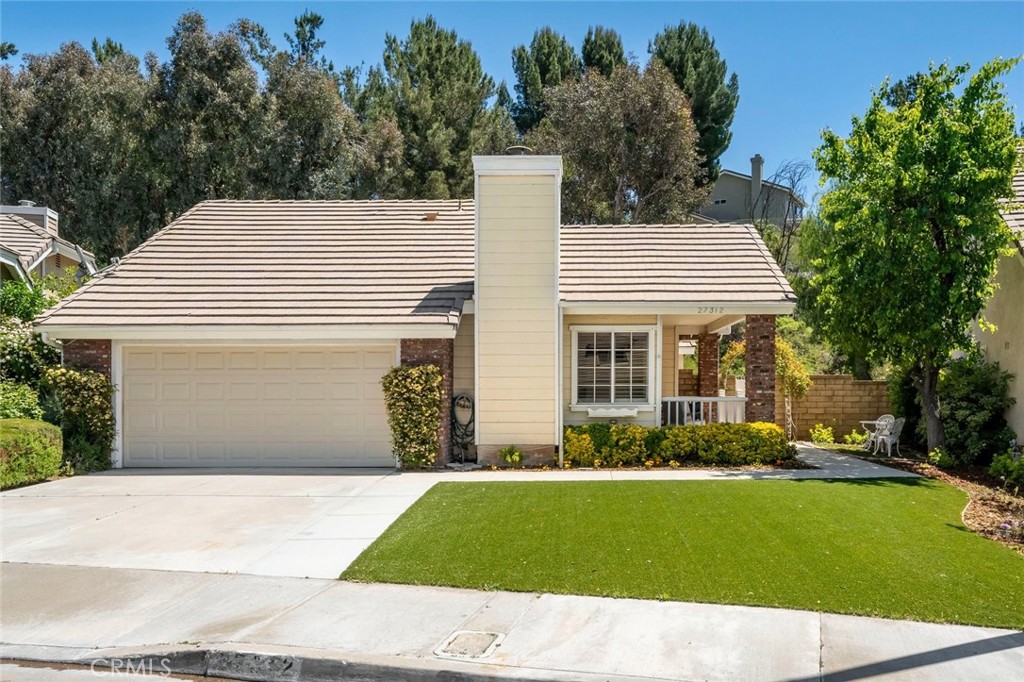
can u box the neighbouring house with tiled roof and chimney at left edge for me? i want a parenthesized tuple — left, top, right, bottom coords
(0, 202, 96, 281)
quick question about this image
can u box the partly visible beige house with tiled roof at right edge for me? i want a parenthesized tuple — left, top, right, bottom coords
(975, 166, 1024, 443)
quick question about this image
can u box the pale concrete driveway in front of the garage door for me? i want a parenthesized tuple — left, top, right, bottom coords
(0, 469, 437, 579)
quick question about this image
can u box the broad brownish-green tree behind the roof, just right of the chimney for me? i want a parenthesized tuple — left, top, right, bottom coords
(526, 61, 708, 223)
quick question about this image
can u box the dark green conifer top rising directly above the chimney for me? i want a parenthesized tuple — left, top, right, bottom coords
(510, 27, 583, 134)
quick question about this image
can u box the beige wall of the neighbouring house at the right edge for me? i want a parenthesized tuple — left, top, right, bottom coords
(980, 254, 1024, 442)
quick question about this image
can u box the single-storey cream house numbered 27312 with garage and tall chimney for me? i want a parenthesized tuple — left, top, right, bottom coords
(37, 156, 795, 467)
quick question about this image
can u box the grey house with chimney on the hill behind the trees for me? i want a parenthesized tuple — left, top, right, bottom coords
(695, 154, 807, 226)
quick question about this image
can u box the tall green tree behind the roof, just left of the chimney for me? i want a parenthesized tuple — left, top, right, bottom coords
(362, 16, 515, 199)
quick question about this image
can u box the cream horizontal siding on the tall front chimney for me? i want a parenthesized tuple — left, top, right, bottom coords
(473, 175, 558, 447)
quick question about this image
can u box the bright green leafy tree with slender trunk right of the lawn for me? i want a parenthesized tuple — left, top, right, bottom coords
(814, 59, 1019, 451)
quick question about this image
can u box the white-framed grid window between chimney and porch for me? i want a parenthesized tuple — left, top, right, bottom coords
(572, 329, 651, 404)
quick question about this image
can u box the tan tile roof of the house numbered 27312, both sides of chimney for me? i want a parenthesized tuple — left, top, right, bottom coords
(38, 200, 795, 331)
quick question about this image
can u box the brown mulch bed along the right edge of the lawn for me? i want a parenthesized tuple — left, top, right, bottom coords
(844, 452, 1024, 554)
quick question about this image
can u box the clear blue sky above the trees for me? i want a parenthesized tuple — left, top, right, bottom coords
(0, 0, 1024, 199)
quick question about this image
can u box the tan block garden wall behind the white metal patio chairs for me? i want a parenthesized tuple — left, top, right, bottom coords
(775, 374, 892, 442)
